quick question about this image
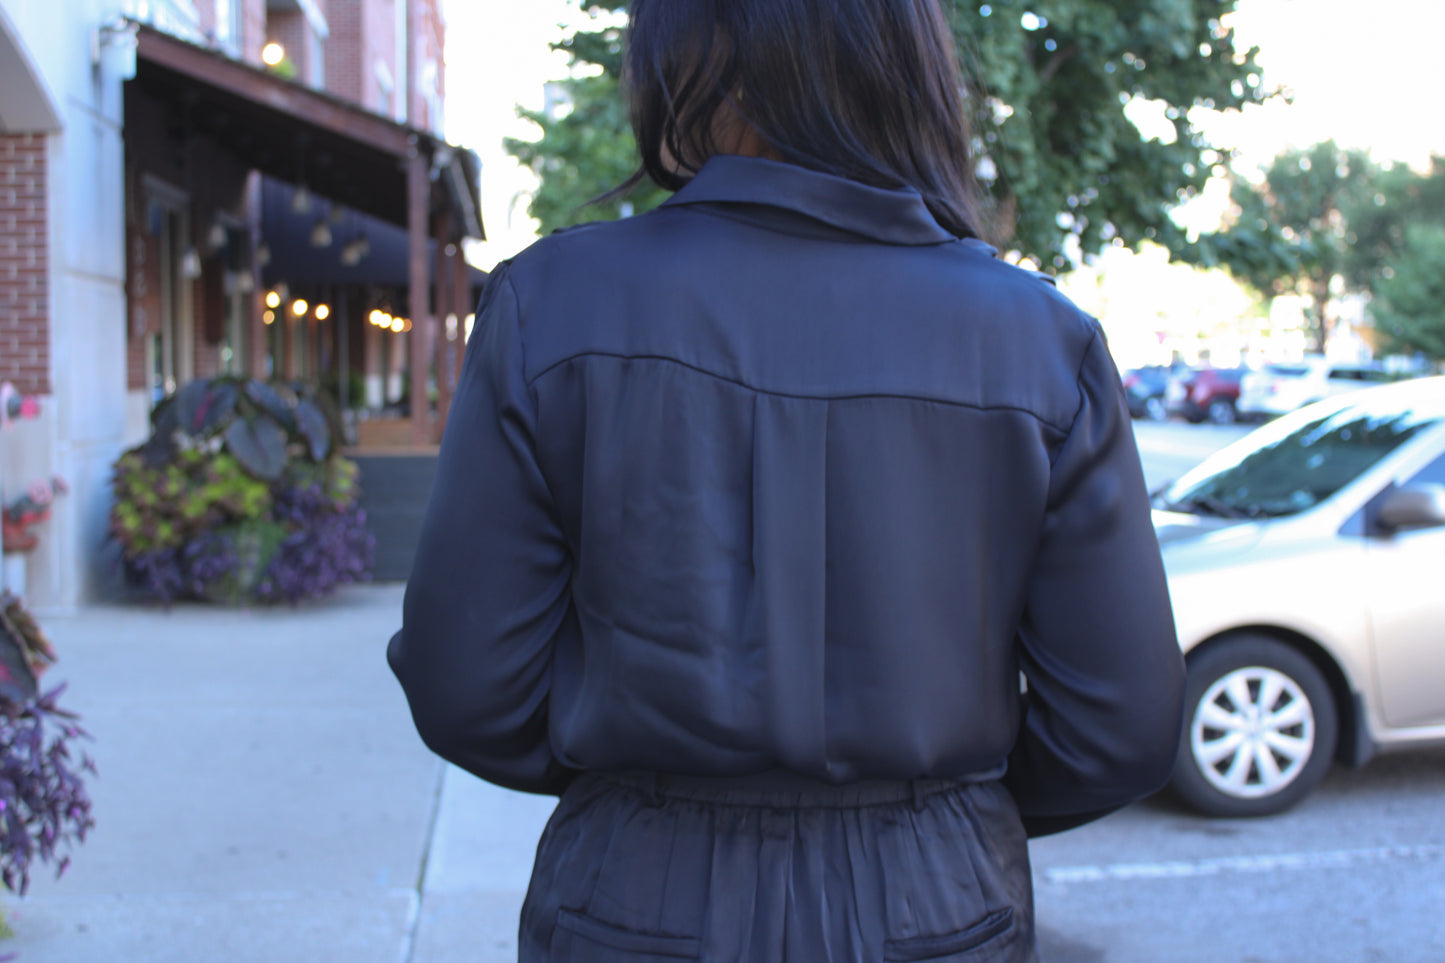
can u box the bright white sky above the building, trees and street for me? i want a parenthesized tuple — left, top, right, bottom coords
(445, 0, 1445, 268)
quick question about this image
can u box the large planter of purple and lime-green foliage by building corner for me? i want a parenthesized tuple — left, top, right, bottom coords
(111, 377, 373, 604)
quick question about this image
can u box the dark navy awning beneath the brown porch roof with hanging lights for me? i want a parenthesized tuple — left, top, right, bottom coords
(262, 178, 487, 292)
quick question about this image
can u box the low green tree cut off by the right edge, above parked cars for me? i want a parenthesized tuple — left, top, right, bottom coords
(1371, 223, 1445, 361)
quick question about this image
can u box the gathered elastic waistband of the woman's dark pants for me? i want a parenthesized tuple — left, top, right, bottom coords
(581, 765, 1004, 808)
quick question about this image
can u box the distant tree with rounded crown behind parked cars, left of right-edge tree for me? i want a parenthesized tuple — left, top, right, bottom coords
(1183, 140, 1380, 350)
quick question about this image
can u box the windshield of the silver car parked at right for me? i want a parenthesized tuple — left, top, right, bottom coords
(1156, 389, 1445, 518)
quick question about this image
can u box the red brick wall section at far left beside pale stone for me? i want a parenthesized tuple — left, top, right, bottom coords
(0, 133, 51, 395)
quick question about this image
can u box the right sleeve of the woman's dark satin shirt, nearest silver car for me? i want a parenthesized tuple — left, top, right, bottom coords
(1006, 333, 1183, 836)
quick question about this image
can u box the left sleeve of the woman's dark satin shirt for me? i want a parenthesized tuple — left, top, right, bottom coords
(387, 265, 577, 794)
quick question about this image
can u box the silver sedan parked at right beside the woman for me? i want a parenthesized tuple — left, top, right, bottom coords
(1155, 377, 1445, 816)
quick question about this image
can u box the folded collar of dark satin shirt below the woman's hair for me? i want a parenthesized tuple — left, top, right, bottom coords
(666, 153, 958, 244)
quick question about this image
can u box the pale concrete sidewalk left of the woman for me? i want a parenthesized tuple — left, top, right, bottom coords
(0, 586, 552, 963)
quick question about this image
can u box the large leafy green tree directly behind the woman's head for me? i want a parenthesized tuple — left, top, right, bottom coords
(507, 0, 1266, 268)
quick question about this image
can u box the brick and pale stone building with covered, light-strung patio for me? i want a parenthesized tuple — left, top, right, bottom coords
(0, 0, 481, 609)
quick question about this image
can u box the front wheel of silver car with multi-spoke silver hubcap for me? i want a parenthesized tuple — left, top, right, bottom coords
(1173, 636, 1338, 817)
